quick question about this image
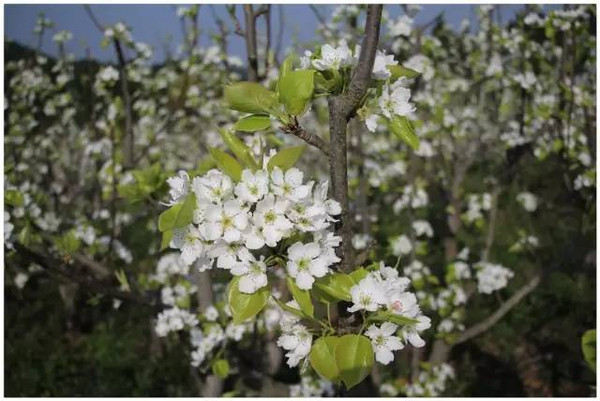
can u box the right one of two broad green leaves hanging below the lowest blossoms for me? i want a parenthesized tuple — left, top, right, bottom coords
(335, 334, 374, 389)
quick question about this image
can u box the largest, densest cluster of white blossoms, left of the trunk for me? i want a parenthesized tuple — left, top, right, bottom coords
(168, 162, 340, 294)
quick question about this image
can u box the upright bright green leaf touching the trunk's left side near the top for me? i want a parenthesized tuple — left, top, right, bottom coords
(277, 70, 315, 116)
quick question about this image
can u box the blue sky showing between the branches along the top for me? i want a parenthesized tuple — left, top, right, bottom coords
(4, 4, 540, 61)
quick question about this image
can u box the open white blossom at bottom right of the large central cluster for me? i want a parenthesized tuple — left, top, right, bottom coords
(286, 242, 329, 290)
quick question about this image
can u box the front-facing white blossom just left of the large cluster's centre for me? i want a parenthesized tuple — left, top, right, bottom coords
(200, 199, 248, 242)
